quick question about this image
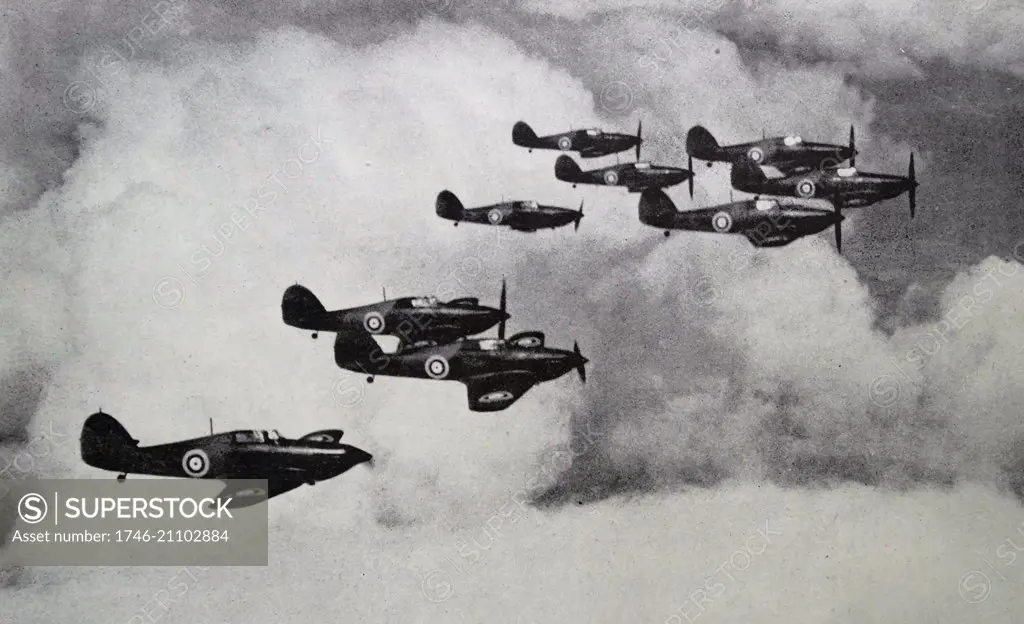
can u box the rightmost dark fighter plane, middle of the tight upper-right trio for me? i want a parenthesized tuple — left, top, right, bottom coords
(730, 154, 918, 218)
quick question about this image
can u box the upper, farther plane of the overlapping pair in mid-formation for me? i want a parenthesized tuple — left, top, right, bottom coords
(281, 282, 509, 344)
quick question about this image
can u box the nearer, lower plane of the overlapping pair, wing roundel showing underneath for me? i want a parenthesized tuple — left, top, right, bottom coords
(325, 284, 588, 412)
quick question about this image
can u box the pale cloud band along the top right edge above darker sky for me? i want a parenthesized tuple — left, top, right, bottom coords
(523, 0, 1024, 78)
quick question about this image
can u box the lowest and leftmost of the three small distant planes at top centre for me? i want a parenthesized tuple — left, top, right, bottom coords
(434, 191, 583, 232)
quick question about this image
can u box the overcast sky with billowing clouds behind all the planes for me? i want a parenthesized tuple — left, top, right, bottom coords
(0, 0, 1024, 624)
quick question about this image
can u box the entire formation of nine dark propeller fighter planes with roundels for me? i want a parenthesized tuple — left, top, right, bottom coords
(80, 121, 918, 507)
